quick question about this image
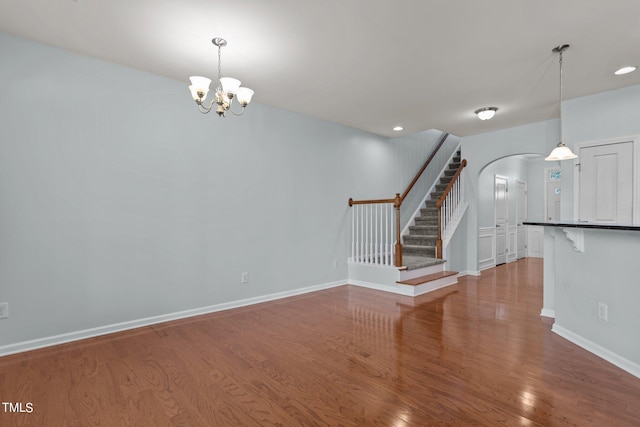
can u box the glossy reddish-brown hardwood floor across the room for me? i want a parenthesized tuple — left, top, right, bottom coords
(0, 258, 640, 427)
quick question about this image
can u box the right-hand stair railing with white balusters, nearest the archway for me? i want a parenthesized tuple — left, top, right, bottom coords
(436, 159, 467, 259)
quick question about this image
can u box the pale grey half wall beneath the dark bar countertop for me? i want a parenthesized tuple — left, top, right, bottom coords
(544, 227, 640, 378)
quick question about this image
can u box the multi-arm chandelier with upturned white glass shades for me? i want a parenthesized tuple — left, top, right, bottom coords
(189, 37, 253, 117)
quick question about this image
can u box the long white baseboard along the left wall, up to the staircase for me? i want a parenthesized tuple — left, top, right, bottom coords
(0, 279, 348, 357)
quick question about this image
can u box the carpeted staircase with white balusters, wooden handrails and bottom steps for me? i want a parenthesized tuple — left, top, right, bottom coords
(348, 135, 466, 296)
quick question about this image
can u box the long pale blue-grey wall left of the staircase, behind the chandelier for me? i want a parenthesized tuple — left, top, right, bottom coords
(0, 33, 440, 353)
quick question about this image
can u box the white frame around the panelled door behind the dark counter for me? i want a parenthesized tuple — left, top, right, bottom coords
(573, 135, 640, 224)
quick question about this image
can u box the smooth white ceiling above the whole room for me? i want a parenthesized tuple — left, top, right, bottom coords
(0, 0, 640, 136)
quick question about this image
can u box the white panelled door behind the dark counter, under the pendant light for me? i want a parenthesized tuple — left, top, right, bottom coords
(578, 141, 633, 224)
